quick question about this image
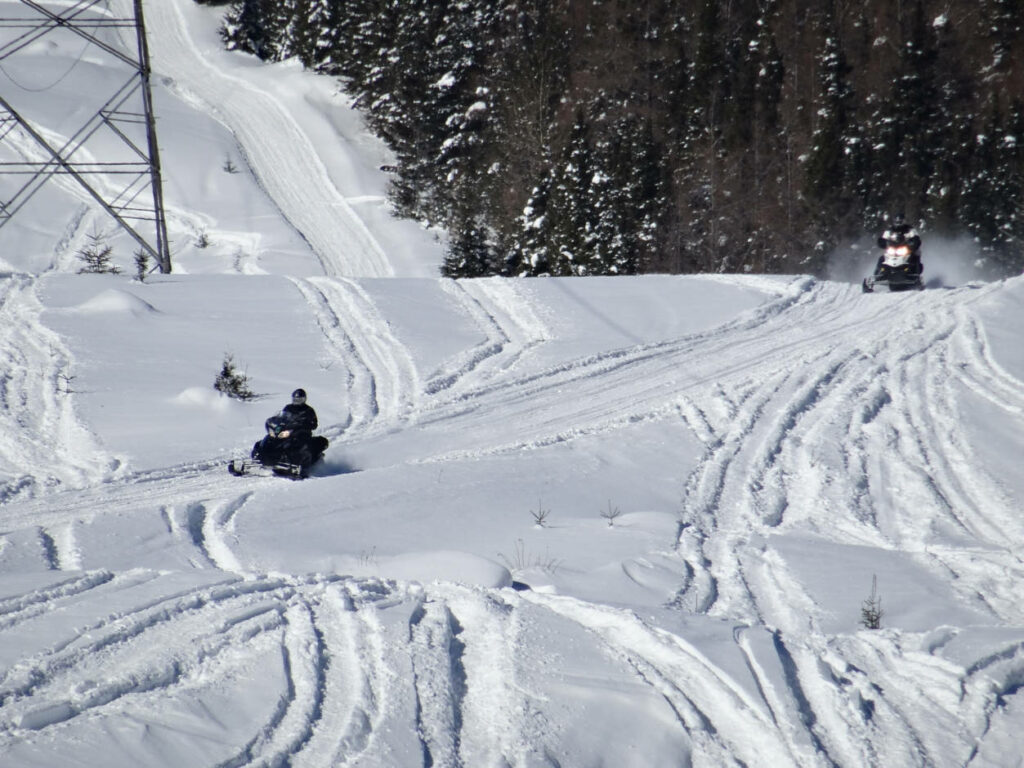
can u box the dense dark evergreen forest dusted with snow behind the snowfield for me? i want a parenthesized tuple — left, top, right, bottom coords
(211, 0, 1024, 276)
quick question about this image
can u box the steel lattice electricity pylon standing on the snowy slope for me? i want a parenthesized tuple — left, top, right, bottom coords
(0, 0, 171, 273)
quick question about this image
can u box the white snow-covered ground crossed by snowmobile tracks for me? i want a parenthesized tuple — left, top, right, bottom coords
(0, 0, 1024, 768)
